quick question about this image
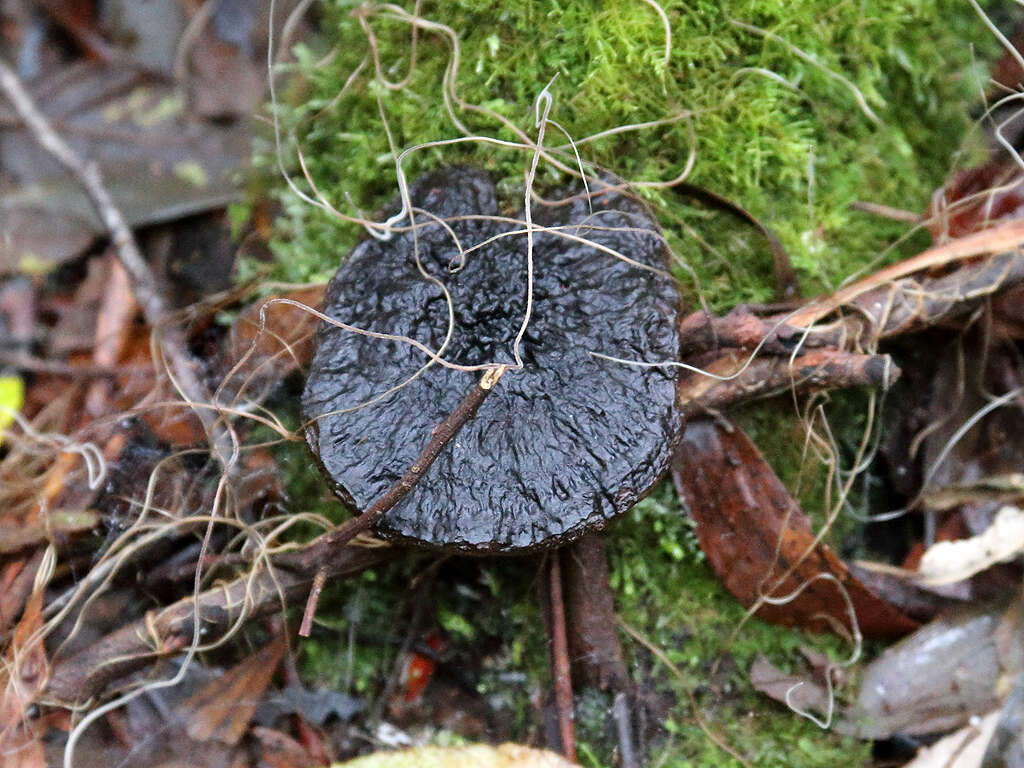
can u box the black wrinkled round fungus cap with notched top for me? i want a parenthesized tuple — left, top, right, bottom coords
(302, 168, 682, 552)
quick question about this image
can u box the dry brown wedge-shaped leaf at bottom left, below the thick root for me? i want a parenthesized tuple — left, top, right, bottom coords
(178, 637, 285, 745)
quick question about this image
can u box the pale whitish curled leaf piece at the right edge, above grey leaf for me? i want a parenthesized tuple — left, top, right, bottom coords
(918, 506, 1024, 585)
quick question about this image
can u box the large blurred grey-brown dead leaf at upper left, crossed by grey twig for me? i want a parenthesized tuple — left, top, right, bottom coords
(0, 61, 251, 274)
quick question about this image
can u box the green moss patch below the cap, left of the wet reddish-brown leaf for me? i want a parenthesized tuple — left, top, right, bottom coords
(600, 484, 869, 768)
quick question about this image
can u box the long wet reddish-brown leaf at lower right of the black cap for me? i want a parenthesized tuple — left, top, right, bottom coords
(673, 419, 918, 637)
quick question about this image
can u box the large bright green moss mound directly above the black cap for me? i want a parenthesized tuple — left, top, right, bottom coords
(249, 0, 990, 309)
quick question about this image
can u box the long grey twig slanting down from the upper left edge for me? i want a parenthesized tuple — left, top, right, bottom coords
(0, 59, 233, 468)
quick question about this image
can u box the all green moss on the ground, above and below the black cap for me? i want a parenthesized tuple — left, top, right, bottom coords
(251, 0, 994, 768)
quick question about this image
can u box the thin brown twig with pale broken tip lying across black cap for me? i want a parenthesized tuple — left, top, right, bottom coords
(299, 366, 508, 637)
